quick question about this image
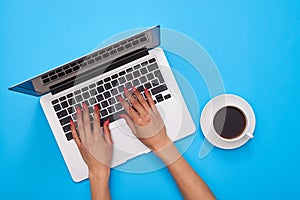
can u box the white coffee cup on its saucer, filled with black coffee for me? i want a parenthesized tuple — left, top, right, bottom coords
(200, 94, 255, 149)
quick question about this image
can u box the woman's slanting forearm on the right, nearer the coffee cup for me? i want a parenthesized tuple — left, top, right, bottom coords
(155, 143, 215, 199)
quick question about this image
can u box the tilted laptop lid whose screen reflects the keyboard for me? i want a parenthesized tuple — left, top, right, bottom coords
(9, 25, 160, 96)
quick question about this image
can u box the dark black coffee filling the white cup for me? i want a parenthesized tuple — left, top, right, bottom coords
(213, 106, 246, 139)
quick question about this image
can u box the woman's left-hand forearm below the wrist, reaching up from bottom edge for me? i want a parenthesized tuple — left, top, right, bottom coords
(89, 174, 110, 200)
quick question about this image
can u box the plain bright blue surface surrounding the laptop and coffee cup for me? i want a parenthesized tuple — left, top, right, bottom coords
(0, 0, 300, 199)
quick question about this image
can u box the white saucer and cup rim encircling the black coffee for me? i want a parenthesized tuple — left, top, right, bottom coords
(200, 94, 255, 149)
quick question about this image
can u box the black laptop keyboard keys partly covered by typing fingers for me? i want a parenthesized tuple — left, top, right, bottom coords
(51, 58, 171, 141)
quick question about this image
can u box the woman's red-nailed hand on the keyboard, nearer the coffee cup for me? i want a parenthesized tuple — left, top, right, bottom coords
(119, 86, 172, 151)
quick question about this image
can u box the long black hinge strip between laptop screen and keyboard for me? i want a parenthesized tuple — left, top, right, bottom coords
(49, 48, 149, 95)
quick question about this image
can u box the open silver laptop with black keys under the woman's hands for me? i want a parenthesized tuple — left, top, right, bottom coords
(9, 26, 196, 182)
